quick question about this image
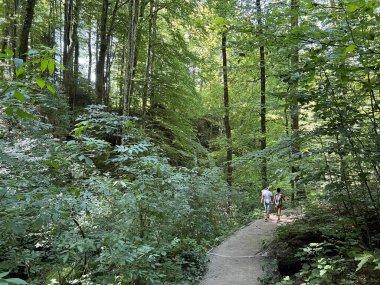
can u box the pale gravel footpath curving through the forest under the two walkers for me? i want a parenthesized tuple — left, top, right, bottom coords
(200, 214, 293, 285)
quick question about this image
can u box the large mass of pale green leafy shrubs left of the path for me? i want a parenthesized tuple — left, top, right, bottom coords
(0, 101, 239, 284)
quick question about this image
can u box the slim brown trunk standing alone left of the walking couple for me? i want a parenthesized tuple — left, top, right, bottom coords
(222, 32, 232, 186)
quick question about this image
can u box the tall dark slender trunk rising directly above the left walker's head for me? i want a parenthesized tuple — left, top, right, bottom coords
(256, 0, 268, 189)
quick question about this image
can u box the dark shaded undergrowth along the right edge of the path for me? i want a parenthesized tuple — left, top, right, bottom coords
(262, 207, 380, 285)
